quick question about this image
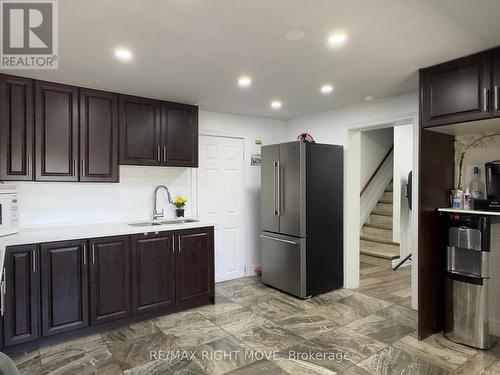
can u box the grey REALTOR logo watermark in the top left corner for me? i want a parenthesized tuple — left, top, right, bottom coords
(0, 0, 58, 69)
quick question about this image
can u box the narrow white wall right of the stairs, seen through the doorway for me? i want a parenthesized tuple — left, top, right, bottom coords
(393, 125, 414, 258)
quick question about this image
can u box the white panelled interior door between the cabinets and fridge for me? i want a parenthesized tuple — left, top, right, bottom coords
(198, 135, 246, 282)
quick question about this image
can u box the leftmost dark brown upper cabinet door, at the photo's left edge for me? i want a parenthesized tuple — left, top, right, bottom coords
(0, 74, 34, 181)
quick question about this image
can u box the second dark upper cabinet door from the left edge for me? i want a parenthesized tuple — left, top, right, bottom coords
(35, 81, 78, 181)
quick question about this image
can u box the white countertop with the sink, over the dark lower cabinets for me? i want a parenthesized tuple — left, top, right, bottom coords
(0, 219, 214, 274)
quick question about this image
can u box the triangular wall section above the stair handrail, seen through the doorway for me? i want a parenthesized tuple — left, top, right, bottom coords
(361, 127, 394, 186)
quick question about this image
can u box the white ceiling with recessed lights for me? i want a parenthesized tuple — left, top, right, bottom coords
(5, 0, 500, 119)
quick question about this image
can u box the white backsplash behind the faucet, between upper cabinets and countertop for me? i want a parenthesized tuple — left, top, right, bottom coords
(18, 166, 196, 226)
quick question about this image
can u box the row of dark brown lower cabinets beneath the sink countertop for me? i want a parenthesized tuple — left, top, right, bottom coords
(0, 227, 214, 348)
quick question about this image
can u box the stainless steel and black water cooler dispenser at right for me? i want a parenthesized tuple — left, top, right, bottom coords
(444, 214, 494, 349)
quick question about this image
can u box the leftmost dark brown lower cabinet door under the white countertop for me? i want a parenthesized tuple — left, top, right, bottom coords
(3, 245, 39, 346)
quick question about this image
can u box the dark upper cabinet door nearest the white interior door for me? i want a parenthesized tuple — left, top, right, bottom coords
(162, 103, 198, 167)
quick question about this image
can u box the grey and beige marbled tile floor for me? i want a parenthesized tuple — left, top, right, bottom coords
(8, 265, 500, 375)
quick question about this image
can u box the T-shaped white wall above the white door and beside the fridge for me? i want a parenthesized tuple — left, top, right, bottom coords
(199, 111, 285, 273)
